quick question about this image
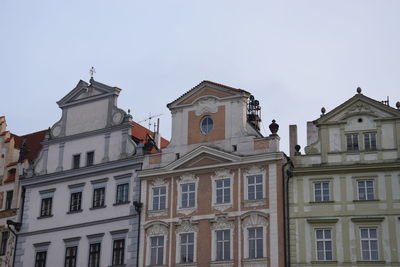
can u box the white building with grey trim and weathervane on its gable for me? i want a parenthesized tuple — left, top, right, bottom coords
(15, 78, 142, 267)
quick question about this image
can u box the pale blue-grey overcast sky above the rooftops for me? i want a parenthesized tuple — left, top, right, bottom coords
(0, 0, 400, 152)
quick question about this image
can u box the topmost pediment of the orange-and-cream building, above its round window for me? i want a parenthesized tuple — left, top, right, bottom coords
(167, 81, 250, 109)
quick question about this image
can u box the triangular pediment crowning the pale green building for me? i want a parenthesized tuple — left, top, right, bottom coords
(316, 93, 400, 125)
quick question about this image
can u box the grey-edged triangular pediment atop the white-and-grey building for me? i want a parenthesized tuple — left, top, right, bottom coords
(57, 79, 121, 107)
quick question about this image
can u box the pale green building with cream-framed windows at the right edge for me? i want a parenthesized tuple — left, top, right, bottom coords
(289, 88, 400, 266)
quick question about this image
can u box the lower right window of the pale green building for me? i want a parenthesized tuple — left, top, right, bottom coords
(360, 228, 379, 261)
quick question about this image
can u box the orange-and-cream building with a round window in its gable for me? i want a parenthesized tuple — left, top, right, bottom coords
(138, 81, 286, 266)
